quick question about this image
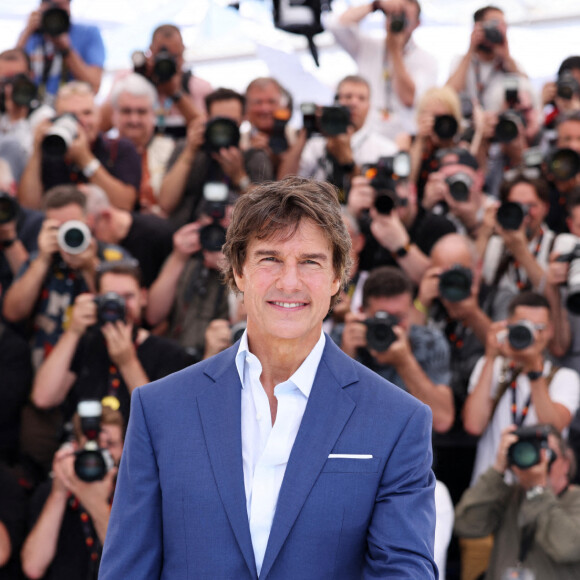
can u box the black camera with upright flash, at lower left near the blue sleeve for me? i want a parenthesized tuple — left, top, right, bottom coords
(75, 401, 114, 483)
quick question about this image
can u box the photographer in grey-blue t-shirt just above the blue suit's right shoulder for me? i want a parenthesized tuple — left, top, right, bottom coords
(336, 266, 454, 432)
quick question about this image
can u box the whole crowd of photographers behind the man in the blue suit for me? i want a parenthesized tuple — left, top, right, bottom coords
(0, 0, 580, 580)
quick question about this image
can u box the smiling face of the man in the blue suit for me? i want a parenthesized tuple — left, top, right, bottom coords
(234, 220, 340, 349)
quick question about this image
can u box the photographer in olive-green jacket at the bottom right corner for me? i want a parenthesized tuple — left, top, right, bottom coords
(455, 425, 580, 580)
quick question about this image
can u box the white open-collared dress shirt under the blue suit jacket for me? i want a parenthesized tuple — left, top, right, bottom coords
(236, 332, 326, 575)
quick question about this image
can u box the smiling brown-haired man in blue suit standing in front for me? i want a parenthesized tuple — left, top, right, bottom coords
(100, 178, 437, 580)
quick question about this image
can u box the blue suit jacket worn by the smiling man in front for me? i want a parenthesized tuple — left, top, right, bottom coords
(99, 337, 437, 580)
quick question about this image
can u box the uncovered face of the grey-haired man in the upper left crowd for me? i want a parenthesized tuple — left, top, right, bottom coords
(114, 93, 155, 148)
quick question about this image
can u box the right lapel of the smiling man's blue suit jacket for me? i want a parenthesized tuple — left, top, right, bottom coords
(260, 336, 358, 579)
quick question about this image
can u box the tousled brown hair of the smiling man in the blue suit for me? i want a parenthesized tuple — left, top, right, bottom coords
(222, 177, 351, 308)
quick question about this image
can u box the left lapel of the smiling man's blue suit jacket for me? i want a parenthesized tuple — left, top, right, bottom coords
(197, 348, 257, 577)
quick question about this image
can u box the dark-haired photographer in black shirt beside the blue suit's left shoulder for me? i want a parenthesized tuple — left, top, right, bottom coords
(31, 260, 191, 421)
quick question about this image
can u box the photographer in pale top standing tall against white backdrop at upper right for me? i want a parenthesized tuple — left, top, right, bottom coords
(447, 6, 525, 110)
